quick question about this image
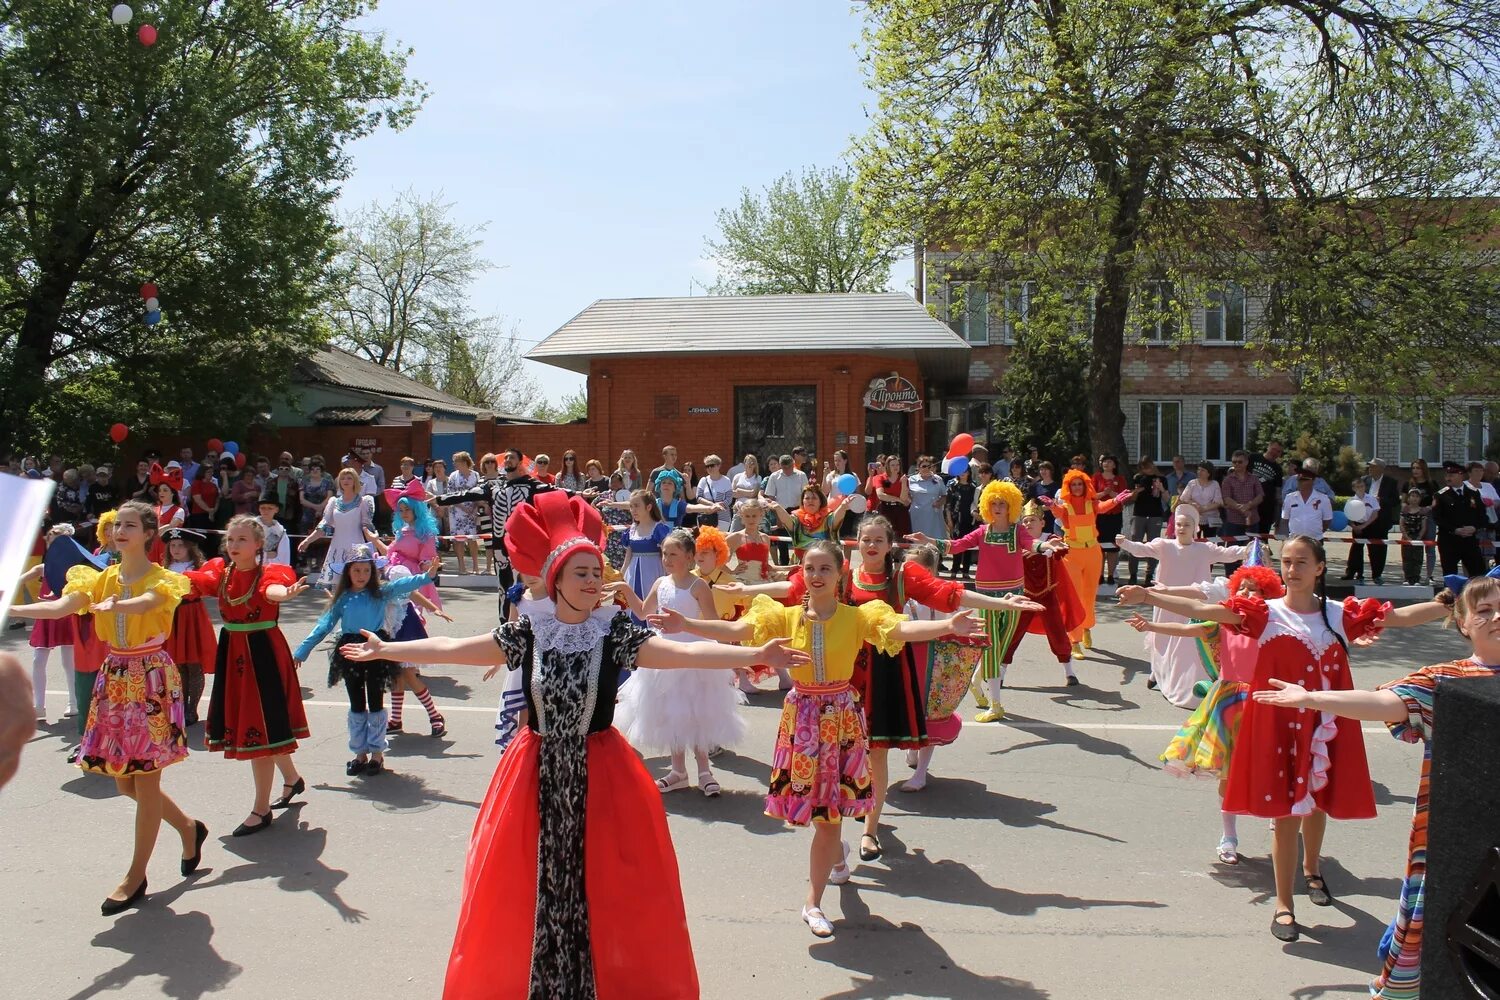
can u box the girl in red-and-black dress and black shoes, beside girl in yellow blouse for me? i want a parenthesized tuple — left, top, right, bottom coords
(186, 514, 308, 837)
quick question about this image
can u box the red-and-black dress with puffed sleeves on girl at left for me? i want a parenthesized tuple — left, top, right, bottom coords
(185, 559, 308, 760)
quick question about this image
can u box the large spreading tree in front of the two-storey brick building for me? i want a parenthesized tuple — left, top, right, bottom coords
(858, 0, 1500, 451)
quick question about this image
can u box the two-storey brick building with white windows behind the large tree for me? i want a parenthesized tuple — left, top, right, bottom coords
(917, 250, 1500, 465)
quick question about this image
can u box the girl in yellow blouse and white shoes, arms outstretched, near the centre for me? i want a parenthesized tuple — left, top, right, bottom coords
(648, 538, 983, 937)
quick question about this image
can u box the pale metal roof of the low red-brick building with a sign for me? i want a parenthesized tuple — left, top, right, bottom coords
(527, 292, 969, 379)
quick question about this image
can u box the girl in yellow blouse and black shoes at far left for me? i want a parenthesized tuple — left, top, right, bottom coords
(11, 501, 209, 916)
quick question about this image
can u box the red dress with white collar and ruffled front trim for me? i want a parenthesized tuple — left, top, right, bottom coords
(1224, 595, 1391, 820)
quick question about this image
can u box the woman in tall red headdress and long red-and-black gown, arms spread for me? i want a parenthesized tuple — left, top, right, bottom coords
(341, 492, 809, 1000)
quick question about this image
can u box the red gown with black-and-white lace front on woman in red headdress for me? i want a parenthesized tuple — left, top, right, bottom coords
(443, 610, 699, 1000)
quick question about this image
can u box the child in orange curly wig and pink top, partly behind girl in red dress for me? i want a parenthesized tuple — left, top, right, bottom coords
(1128, 538, 1287, 865)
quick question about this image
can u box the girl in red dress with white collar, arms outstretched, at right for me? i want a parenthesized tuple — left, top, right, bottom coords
(1121, 535, 1449, 942)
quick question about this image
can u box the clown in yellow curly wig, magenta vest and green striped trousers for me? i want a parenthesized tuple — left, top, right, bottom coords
(908, 480, 1068, 723)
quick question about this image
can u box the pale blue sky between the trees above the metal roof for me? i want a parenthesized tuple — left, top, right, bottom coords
(344, 0, 872, 400)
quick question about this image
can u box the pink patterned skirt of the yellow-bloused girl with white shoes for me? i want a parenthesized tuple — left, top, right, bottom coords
(765, 685, 875, 826)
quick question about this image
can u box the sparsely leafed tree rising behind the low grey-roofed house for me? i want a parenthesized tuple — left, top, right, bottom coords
(324, 190, 537, 414)
